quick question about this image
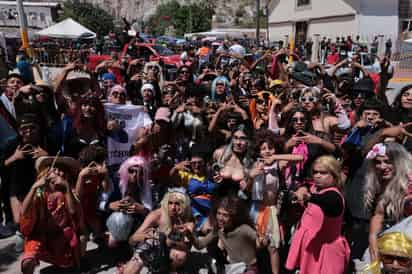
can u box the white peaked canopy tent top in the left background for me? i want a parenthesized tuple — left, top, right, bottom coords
(37, 18, 96, 39)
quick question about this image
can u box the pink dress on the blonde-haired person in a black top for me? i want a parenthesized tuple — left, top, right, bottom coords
(286, 187, 350, 274)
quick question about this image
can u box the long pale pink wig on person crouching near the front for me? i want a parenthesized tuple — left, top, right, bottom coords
(119, 156, 153, 210)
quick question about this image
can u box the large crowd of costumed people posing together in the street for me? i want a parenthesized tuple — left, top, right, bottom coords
(0, 30, 412, 274)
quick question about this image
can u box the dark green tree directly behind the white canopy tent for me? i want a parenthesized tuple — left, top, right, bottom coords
(58, 0, 114, 36)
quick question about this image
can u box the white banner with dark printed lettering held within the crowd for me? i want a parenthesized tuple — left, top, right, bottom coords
(104, 103, 152, 166)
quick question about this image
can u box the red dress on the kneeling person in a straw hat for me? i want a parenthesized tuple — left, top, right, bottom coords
(20, 192, 81, 267)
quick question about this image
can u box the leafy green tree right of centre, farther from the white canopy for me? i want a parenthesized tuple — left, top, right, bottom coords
(146, 0, 214, 36)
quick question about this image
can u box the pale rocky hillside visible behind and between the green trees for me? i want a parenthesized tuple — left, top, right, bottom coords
(29, 0, 266, 27)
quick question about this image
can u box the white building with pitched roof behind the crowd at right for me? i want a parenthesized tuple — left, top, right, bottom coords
(269, 0, 399, 42)
